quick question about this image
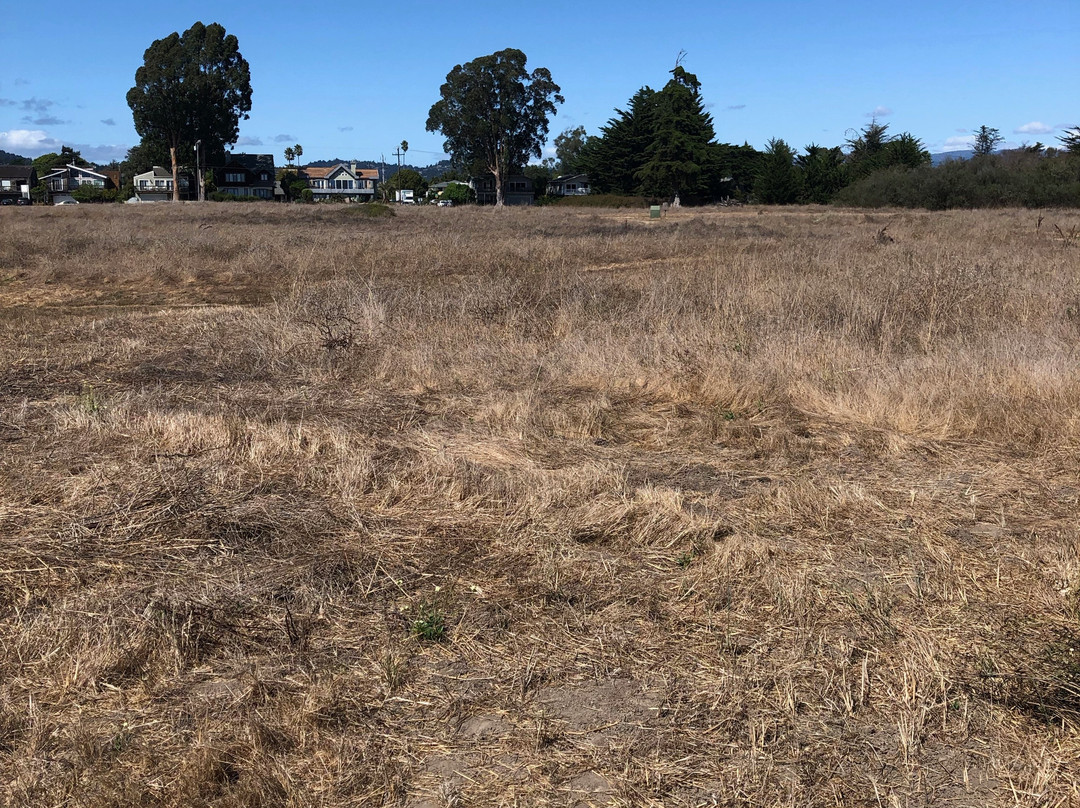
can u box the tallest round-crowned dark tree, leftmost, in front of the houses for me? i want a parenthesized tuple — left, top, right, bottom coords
(127, 23, 252, 201)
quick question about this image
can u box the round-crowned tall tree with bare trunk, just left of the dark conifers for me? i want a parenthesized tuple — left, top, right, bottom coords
(427, 48, 563, 206)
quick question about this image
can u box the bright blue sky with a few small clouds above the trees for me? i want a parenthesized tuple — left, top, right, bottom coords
(0, 0, 1080, 164)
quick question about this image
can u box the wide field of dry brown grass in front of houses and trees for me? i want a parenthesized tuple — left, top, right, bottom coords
(0, 204, 1080, 808)
